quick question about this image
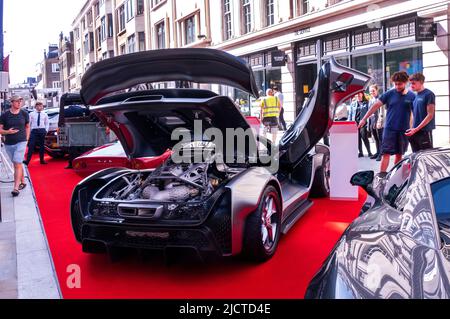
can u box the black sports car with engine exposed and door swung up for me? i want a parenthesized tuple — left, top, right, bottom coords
(71, 49, 370, 261)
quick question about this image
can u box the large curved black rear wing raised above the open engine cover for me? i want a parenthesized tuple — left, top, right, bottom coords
(80, 48, 258, 105)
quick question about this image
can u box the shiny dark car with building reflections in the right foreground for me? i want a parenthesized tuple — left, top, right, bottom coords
(305, 149, 450, 299)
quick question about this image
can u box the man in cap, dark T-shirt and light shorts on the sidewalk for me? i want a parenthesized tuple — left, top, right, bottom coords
(0, 95, 30, 197)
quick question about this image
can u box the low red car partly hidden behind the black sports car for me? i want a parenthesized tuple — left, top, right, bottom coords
(72, 142, 172, 176)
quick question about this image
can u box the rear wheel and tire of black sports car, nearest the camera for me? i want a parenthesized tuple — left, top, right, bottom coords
(243, 186, 281, 262)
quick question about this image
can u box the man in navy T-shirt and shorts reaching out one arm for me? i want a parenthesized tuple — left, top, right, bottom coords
(358, 71, 415, 177)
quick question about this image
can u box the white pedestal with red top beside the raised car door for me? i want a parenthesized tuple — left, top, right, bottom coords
(330, 122, 358, 200)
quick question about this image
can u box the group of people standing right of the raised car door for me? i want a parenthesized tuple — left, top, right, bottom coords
(344, 71, 436, 176)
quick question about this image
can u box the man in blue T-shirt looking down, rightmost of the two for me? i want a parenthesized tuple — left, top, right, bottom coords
(406, 73, 436, 152)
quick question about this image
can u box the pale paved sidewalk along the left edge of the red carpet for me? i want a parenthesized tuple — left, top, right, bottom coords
(0, 146, 61, 299)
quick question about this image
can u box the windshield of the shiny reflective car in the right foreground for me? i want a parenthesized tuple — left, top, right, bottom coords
(383, 158, 411, 211)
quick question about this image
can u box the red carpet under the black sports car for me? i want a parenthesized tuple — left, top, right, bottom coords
(29, 155, 365, 299)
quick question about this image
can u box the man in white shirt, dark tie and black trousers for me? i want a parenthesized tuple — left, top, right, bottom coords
(23, 102, 49, 165)
